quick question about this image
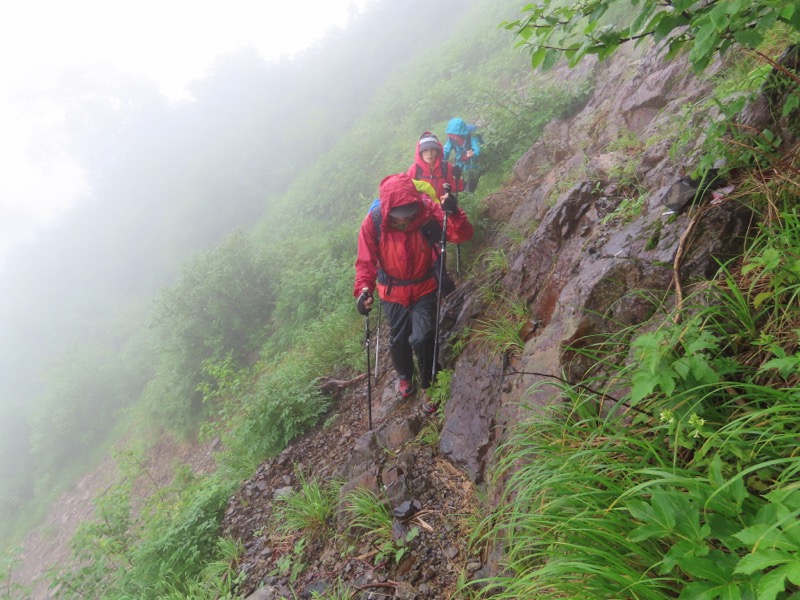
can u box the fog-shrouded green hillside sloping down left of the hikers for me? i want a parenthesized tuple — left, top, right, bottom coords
(0, 2, 544, 564)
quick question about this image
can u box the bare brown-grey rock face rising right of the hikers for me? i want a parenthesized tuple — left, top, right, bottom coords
(441, 43, 750, 492)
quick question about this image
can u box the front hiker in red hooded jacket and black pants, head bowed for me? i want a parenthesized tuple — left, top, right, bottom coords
(353, 173, 473, 412)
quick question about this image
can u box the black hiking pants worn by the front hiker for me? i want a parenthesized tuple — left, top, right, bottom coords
(383, 292, 436, 390)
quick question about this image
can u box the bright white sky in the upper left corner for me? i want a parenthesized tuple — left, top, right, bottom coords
(0, 0, 368, 270)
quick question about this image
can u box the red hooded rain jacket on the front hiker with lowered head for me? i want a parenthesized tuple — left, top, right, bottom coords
(353, 173, 473, 306)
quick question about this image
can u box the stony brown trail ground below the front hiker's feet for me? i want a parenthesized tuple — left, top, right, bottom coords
(223, 376, 483, 599)
